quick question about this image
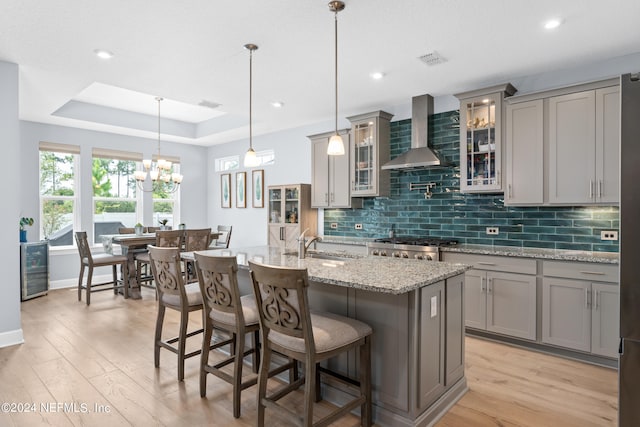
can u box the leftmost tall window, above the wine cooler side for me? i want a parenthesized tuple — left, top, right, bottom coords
(40, 142, 80, 246)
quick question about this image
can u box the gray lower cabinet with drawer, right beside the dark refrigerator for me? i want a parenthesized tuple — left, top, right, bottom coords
(542, 261, 620, 358)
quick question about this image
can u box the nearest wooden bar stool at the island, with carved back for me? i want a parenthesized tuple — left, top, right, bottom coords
(249, 261, 372, 427)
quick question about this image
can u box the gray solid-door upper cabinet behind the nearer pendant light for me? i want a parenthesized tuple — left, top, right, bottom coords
(308, 130, 352, 208)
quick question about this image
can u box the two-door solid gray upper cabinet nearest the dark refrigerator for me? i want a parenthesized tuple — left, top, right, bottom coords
(548, 86, 620, 204)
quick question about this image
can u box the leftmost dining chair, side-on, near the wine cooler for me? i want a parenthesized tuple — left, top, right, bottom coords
(75, 231, 129, 305)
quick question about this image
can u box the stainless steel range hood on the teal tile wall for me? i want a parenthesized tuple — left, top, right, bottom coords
(381, 95, 448, 169)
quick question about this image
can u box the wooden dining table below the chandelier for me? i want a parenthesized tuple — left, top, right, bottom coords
(102, 230, 221, 299)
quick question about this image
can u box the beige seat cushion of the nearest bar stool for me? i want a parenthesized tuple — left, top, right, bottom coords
(269, 311, 372, 354)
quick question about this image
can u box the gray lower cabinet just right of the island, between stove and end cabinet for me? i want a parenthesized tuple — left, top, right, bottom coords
(444, 252, 537, 340)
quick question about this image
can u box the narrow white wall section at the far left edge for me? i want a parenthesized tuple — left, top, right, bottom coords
(0, 61, 23, 347)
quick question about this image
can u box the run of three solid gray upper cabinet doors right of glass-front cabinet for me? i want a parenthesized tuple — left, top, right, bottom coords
(505, 80, 620, 206)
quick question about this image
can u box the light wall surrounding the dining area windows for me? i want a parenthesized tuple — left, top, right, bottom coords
(20, 121, 210, 284)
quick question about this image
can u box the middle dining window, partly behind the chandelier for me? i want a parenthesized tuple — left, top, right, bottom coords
(91, 148, 142, 243)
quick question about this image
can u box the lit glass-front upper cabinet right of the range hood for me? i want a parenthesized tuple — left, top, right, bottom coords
(455, 83, 516, 193)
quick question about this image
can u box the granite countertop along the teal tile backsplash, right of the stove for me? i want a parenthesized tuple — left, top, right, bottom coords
(440, 244, 620, 264)
